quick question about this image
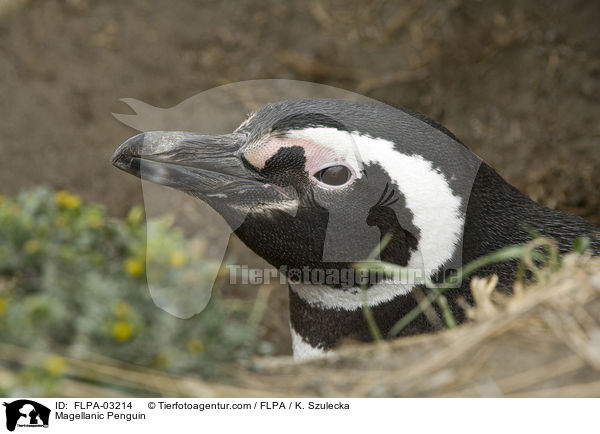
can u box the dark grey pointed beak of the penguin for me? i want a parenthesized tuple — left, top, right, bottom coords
(111, 131, 264, 198)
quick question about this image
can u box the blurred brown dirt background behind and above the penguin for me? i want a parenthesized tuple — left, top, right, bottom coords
(0, 0, 600, 352)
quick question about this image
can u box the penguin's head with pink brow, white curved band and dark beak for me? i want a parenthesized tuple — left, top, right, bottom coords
(112, 99, 480, 282)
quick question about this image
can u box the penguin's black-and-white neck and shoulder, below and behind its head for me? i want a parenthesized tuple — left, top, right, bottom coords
(290, 163, 600, 358)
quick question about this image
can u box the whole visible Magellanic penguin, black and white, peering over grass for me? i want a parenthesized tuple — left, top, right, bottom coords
(112, 99, 600, 359)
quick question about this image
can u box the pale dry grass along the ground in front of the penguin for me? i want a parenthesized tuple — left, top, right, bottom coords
(0, 254, 600, 397)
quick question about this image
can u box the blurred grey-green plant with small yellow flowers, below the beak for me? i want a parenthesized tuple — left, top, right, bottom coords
(0, 188, 268, 394)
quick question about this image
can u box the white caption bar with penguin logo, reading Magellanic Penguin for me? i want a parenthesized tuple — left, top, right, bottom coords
(0, 398, 600, 434)
